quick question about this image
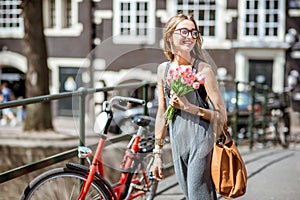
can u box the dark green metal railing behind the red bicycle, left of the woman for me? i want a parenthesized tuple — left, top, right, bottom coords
(0, 81, 156, 183)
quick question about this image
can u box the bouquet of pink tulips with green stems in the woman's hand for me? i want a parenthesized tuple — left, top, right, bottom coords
(165, 65, 205, 125)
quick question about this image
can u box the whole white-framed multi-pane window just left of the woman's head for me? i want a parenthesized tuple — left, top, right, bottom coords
(113, 0, 155, 44)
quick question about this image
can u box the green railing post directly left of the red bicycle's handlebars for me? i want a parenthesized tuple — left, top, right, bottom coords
(78, 87, 87, 165)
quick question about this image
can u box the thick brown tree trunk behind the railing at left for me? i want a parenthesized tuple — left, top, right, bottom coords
(21, 0, 53, 131)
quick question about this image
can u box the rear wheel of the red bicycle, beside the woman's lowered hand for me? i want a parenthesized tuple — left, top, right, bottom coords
(137, 154, 158, 200)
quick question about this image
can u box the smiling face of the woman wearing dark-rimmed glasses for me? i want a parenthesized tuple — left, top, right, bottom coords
(171, 19, 198, 53)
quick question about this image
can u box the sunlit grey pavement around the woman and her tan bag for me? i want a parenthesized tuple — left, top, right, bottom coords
(156, 144, 300, 200)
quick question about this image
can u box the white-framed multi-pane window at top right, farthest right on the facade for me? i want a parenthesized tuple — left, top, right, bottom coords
(241, 0, 284, 39)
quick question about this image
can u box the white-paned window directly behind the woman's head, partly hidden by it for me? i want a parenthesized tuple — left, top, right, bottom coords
(176, 0, 217, 37)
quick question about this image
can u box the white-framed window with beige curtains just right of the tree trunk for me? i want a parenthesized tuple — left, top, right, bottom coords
(43, 0, 82, 36)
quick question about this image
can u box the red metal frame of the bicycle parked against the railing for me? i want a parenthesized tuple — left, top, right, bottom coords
(78, 101, 155, 200)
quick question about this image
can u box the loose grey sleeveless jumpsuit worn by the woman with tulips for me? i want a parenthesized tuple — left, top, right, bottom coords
(165, 60, 217, 200)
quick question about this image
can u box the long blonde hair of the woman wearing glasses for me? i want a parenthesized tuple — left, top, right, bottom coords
(163, 13, 204, 61)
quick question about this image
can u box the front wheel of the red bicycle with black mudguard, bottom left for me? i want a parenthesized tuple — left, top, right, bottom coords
(21, 168, 111, 200)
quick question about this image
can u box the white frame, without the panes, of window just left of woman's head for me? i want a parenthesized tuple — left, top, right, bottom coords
(113, 0, 155, 44)
